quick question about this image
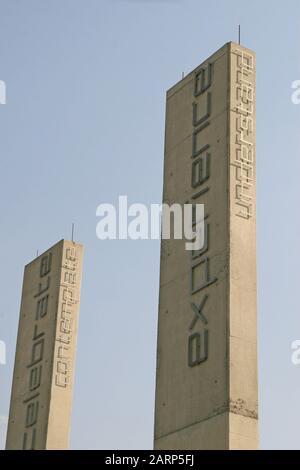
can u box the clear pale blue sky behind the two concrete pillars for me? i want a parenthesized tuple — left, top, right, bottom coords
(0, 0, 300, 449)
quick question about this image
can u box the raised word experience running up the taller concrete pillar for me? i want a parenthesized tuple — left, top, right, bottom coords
(187, 63, 217, 368)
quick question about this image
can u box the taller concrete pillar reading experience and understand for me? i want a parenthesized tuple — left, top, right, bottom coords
(154, 43, 258, 450)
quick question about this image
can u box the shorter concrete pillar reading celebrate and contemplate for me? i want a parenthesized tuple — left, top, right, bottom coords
(6, 240, 83, 450)
